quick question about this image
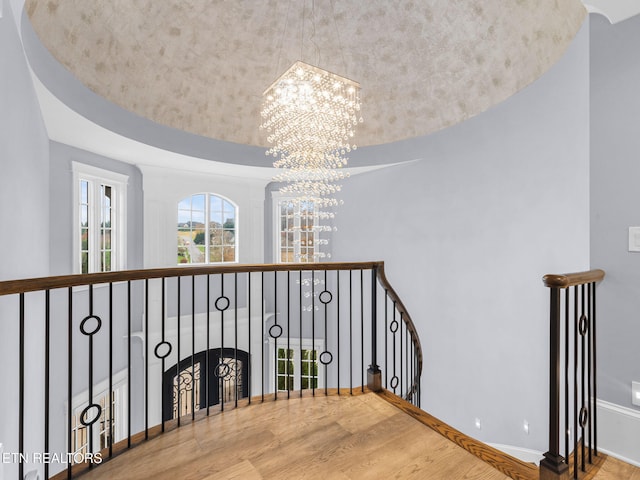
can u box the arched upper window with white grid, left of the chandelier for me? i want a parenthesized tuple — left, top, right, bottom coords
(178, 193, 238, 264)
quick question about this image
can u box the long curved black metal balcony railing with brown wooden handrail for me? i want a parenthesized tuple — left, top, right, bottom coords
(0, 262, 422, 479)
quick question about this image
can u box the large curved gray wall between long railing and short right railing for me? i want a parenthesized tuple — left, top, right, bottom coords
(332, 24, 589, 451)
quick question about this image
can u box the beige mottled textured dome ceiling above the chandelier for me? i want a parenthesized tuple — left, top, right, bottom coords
(26, 0, 586, 146)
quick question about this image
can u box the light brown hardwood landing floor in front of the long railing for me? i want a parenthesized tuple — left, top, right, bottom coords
(77, 393, 509, 480)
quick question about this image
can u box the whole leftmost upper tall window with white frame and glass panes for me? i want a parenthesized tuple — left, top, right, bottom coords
(73, 162, 128, 273)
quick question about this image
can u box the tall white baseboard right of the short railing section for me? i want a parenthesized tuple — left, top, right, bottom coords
(596, 400, 640, 467)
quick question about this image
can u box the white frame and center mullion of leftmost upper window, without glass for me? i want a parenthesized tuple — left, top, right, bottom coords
(71, 161, 129, 273)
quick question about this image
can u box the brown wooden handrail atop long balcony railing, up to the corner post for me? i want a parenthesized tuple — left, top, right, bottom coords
(0, 261, 384, 296)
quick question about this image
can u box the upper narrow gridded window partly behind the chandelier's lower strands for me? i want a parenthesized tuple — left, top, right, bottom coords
(277, 199, 319, 263)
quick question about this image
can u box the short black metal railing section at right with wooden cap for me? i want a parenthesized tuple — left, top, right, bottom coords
(540, 270, 604, 479)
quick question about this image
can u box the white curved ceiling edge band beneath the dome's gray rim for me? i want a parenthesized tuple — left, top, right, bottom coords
(31, 70, 405, 182)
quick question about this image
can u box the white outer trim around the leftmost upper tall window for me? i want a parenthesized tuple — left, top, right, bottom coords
(71, 161, 129, 273)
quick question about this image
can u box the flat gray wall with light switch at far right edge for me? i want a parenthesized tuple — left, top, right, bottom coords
(591, 15, 640, 409)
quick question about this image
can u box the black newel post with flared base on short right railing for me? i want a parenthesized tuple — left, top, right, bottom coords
(540, 287, 569, 480)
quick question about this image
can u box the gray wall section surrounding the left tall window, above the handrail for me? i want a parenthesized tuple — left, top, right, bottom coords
(48, 142, 144, 275)
